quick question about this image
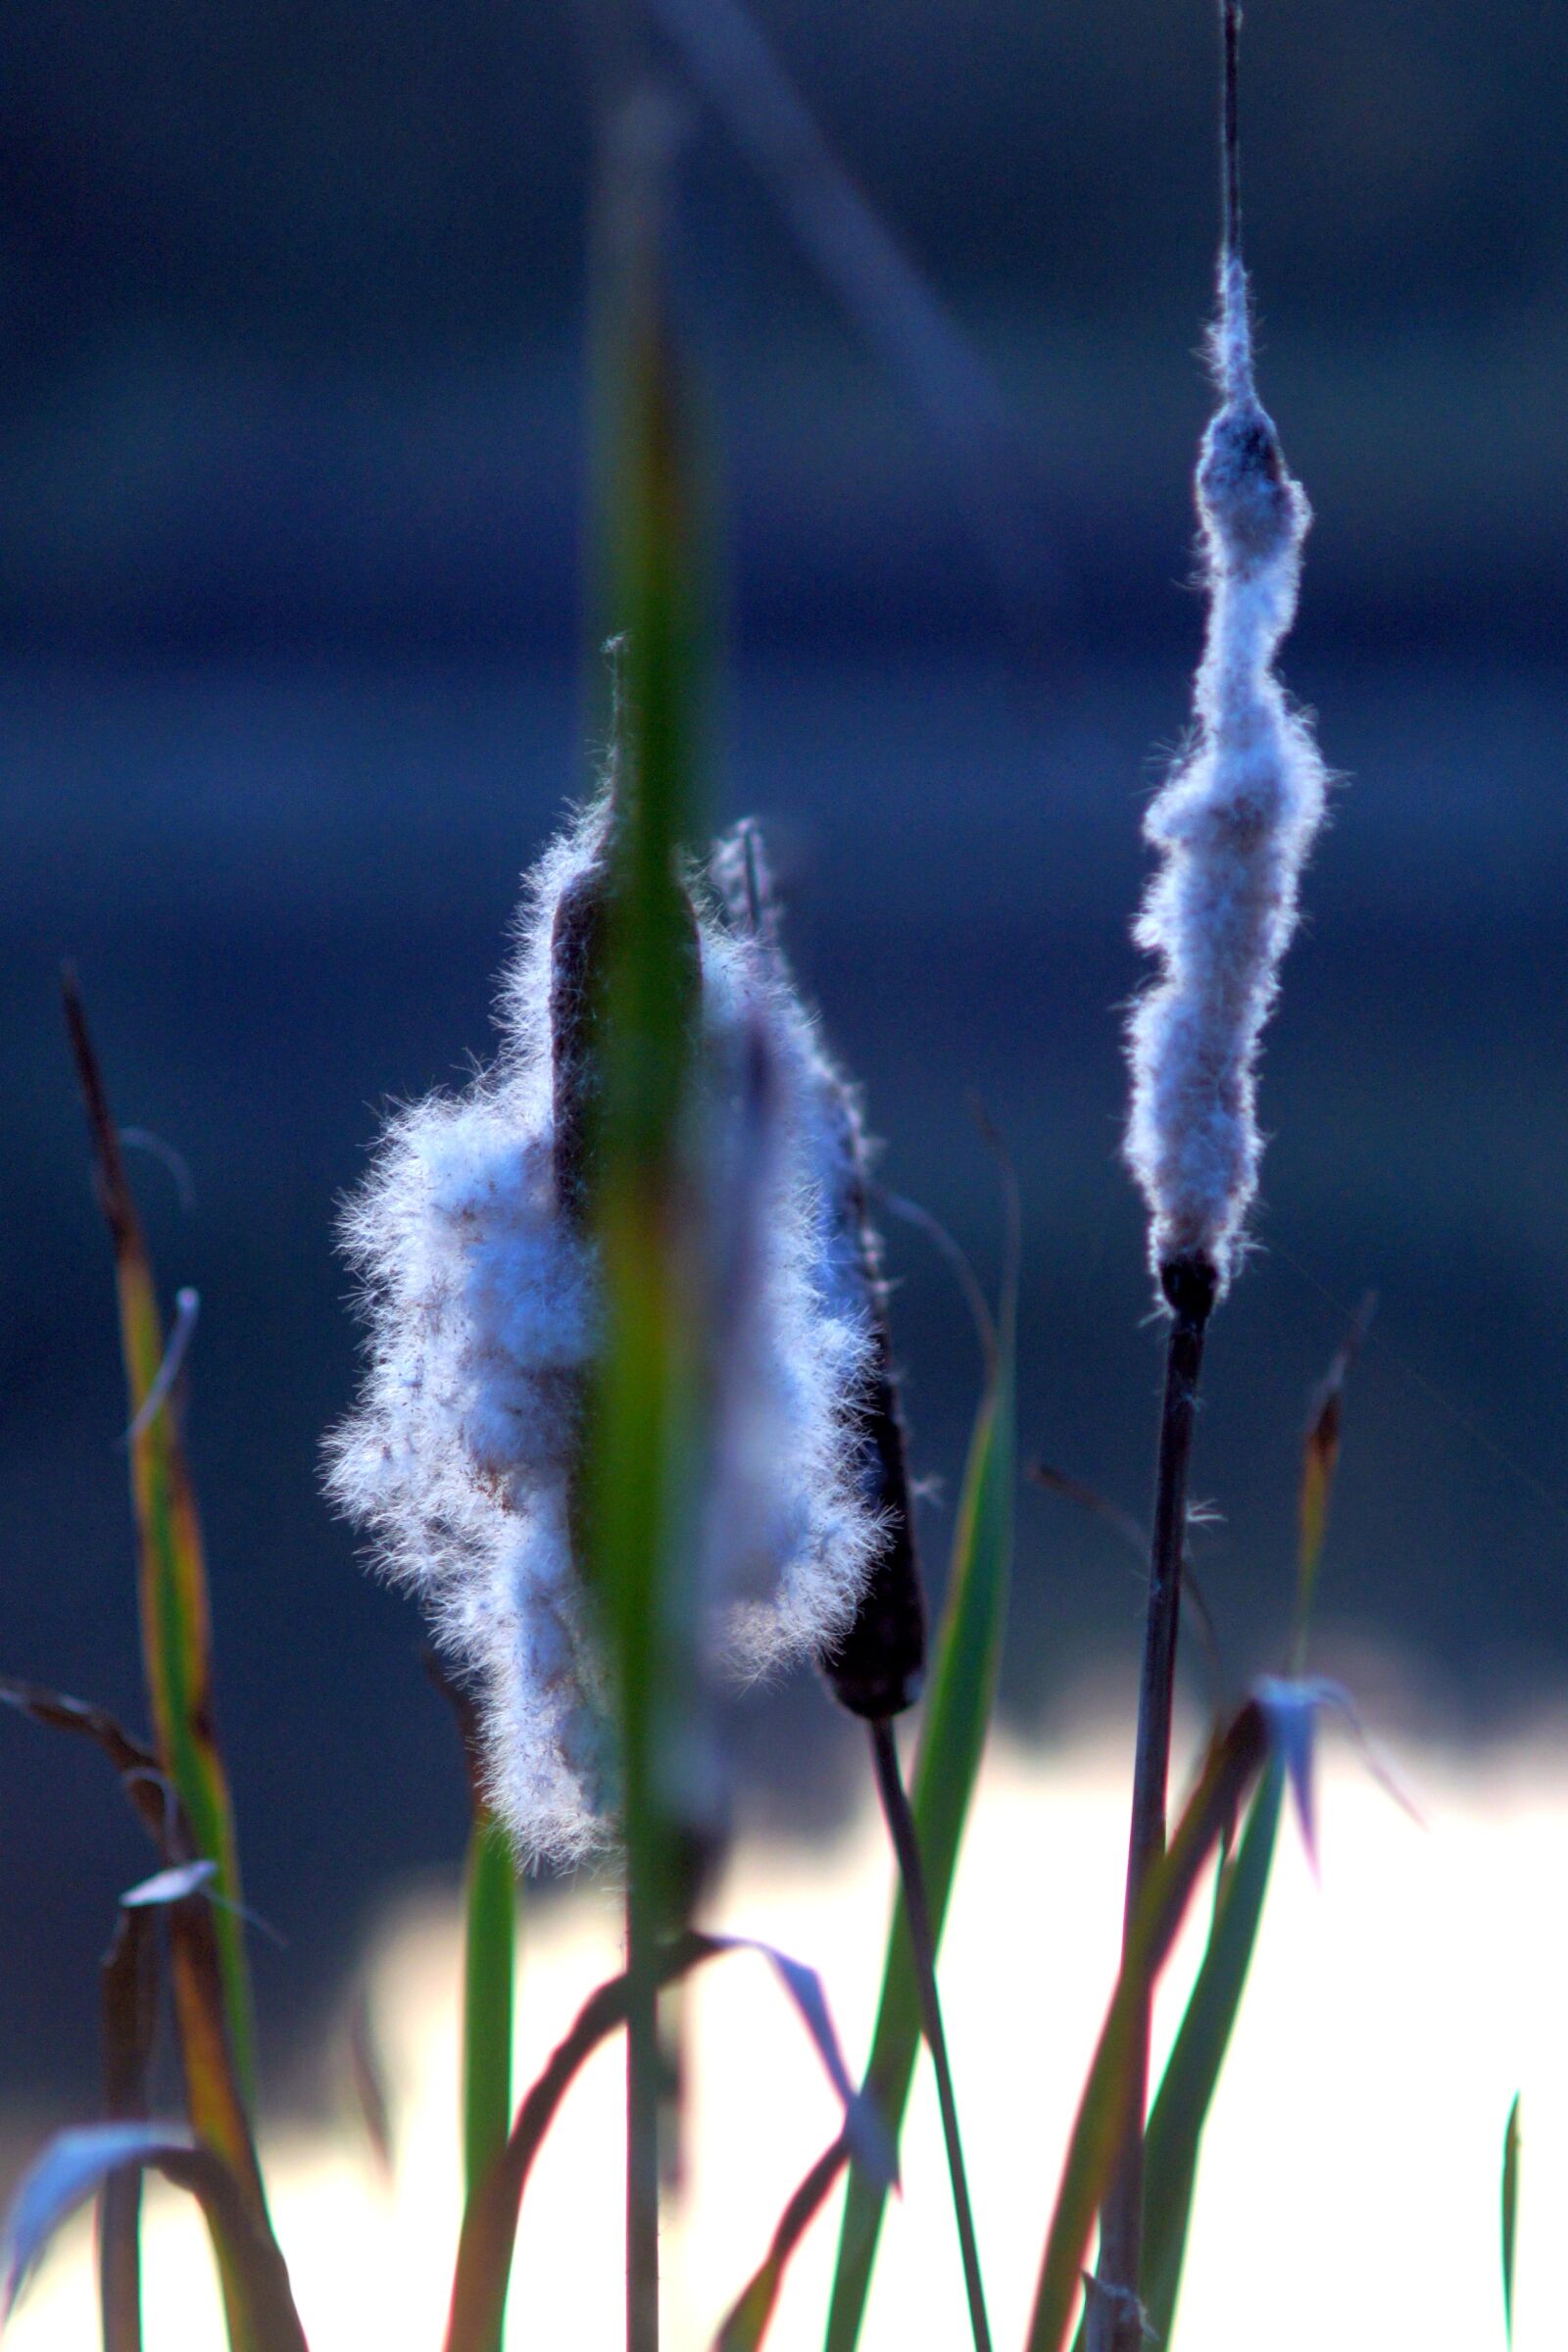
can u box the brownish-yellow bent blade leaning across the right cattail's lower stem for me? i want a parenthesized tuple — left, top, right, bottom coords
(1025, 1700, 1269, 2352)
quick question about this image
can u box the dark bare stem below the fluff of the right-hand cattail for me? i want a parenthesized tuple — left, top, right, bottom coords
(1089, 1258, 1215, 2352)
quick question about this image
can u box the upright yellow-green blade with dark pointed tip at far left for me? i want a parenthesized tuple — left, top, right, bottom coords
(64, 974, 256, 2107)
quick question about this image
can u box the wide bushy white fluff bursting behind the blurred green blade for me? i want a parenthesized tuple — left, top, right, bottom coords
(326, 798, 877, 1863)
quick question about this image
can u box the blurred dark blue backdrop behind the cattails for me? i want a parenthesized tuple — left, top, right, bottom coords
(0, 0, 1568, 2112)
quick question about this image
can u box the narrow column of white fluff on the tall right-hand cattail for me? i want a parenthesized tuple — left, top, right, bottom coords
(1126, 254, 1326, 1292)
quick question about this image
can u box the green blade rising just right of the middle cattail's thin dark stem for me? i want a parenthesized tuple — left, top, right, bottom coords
(827, 1275, 1013, 2352)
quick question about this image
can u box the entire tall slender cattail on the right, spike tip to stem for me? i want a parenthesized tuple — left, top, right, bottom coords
(1089, 0, 1326, 2352)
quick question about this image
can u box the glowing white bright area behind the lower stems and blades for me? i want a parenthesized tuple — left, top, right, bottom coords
(10, 1727, 1568, 2352)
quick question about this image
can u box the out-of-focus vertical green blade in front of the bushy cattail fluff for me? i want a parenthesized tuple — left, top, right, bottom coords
(573, 87, 710, 2352)
